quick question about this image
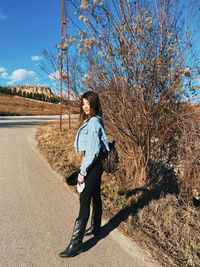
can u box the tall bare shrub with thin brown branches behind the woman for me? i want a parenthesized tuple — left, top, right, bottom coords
(68, 0, 199, 200)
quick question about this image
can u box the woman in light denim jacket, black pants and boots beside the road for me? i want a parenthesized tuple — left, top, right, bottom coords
(59, 91, 109, 258)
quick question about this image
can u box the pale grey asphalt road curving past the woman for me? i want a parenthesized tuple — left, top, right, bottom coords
(0, 116, 158, 267)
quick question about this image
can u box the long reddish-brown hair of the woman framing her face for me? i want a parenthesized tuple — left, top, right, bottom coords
(80, 91, 102, 122)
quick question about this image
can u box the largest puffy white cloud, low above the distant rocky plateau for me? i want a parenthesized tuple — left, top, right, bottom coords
(7, 69, 38, 85)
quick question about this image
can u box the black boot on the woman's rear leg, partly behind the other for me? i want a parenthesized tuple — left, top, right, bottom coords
(84, 209, 102, 236)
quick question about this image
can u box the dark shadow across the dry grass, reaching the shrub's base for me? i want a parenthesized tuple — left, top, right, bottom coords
(104, 161, 179, 232)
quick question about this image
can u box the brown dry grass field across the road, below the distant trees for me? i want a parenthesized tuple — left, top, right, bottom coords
(0, 93, 78, 116)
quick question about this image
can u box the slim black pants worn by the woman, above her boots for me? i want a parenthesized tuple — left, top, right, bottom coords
(79, 159, 103, 221)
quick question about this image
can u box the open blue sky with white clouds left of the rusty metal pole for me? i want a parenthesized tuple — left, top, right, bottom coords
(0, 0, 76, 92)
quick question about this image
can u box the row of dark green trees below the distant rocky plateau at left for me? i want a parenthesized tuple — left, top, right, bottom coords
(0, 86, 60, 104)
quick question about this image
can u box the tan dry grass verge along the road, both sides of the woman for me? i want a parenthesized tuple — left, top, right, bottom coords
(36, 120, 200, 267)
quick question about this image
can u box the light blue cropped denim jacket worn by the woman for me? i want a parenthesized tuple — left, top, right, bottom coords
(74, 115, 109, 176)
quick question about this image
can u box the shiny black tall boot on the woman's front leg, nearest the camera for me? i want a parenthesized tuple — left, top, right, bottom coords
(59, 218, 87, 258)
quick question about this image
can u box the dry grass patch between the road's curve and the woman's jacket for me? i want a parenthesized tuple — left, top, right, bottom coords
(36, 119, 81, 180)
